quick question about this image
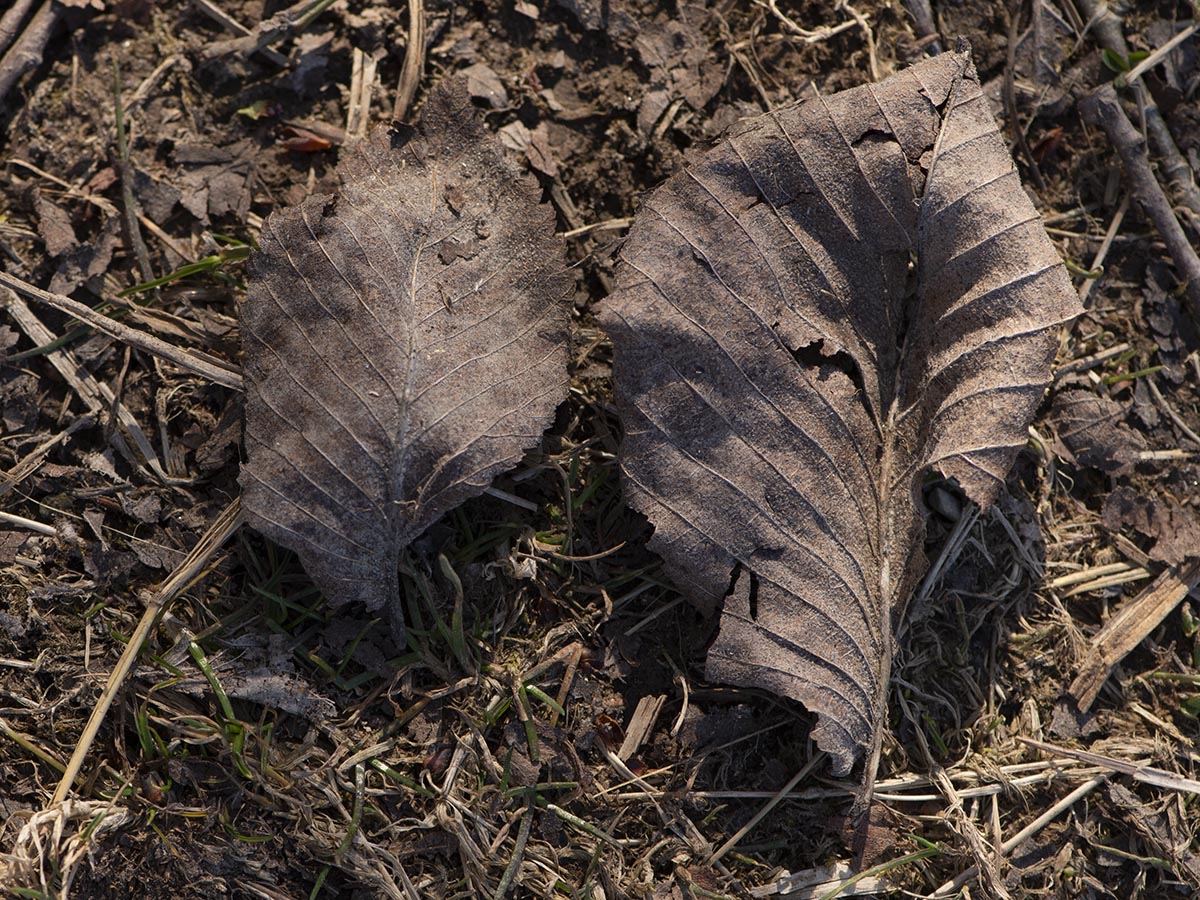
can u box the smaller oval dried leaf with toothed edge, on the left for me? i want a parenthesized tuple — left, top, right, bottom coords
(241, 85, 571, 622)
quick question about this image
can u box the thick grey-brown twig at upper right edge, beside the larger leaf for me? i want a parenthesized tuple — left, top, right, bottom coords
(1081, 84, 1200, 322)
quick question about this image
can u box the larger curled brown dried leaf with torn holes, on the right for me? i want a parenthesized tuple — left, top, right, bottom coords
(605, 52, 1078, 782)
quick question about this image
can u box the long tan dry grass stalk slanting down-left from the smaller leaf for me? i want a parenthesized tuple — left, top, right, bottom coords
(50, 499, 242, 806)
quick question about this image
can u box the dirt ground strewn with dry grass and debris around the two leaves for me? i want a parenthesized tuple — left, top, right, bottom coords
(0, 0, 1200, 900)
